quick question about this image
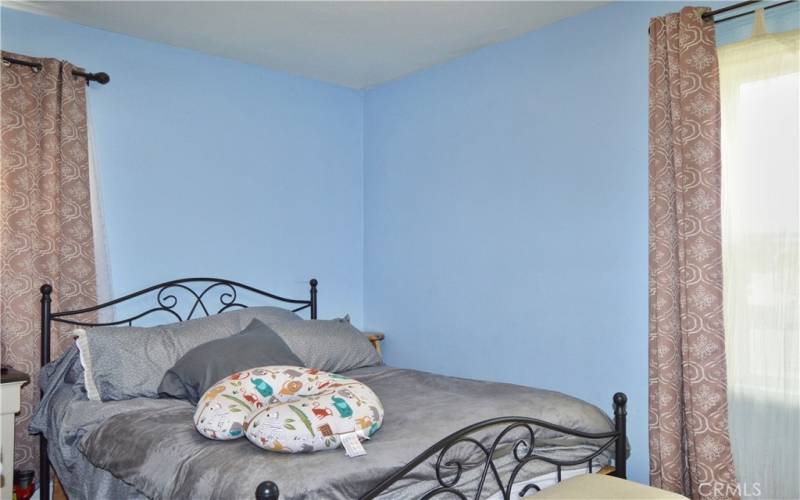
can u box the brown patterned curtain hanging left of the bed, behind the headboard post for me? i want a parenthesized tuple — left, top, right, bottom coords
(0, 53, 96, 469)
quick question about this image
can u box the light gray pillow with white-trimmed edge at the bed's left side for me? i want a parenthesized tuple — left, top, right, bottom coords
(75, 307, 300, 401)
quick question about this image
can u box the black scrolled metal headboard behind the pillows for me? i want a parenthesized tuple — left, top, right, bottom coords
(39, 278, 317, 491)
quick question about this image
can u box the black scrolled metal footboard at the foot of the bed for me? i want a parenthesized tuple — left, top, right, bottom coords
(255, 392, 628, 500)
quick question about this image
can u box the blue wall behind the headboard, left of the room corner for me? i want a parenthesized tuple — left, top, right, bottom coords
(2, 8, 363, 323)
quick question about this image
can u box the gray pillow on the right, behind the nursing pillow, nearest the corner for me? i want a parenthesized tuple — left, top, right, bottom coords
(269, 319, 381, 373)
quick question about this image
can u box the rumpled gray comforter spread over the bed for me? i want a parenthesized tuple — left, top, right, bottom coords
(31, 348, 613, 499)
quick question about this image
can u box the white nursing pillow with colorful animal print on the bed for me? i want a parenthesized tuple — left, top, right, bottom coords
(194, 366, 383, 453)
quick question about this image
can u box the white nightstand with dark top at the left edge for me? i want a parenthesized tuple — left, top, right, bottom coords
(0, 368, 31, 499)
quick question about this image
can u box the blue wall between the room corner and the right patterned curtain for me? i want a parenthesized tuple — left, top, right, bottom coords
(364, 2, 680, 482)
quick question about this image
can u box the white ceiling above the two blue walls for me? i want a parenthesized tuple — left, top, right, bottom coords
(4, 1, 607, 89)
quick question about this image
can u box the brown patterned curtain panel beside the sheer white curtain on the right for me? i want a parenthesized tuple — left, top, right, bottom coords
(649, 7, 739, 499)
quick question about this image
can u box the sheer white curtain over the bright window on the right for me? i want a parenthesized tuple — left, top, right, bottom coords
(719, 11, 800, 498)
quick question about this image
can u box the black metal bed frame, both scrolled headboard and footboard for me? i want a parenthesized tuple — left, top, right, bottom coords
(39, 278, 628, 500)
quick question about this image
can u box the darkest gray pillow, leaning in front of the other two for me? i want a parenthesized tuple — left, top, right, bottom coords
(158, 319, 303, 404)
